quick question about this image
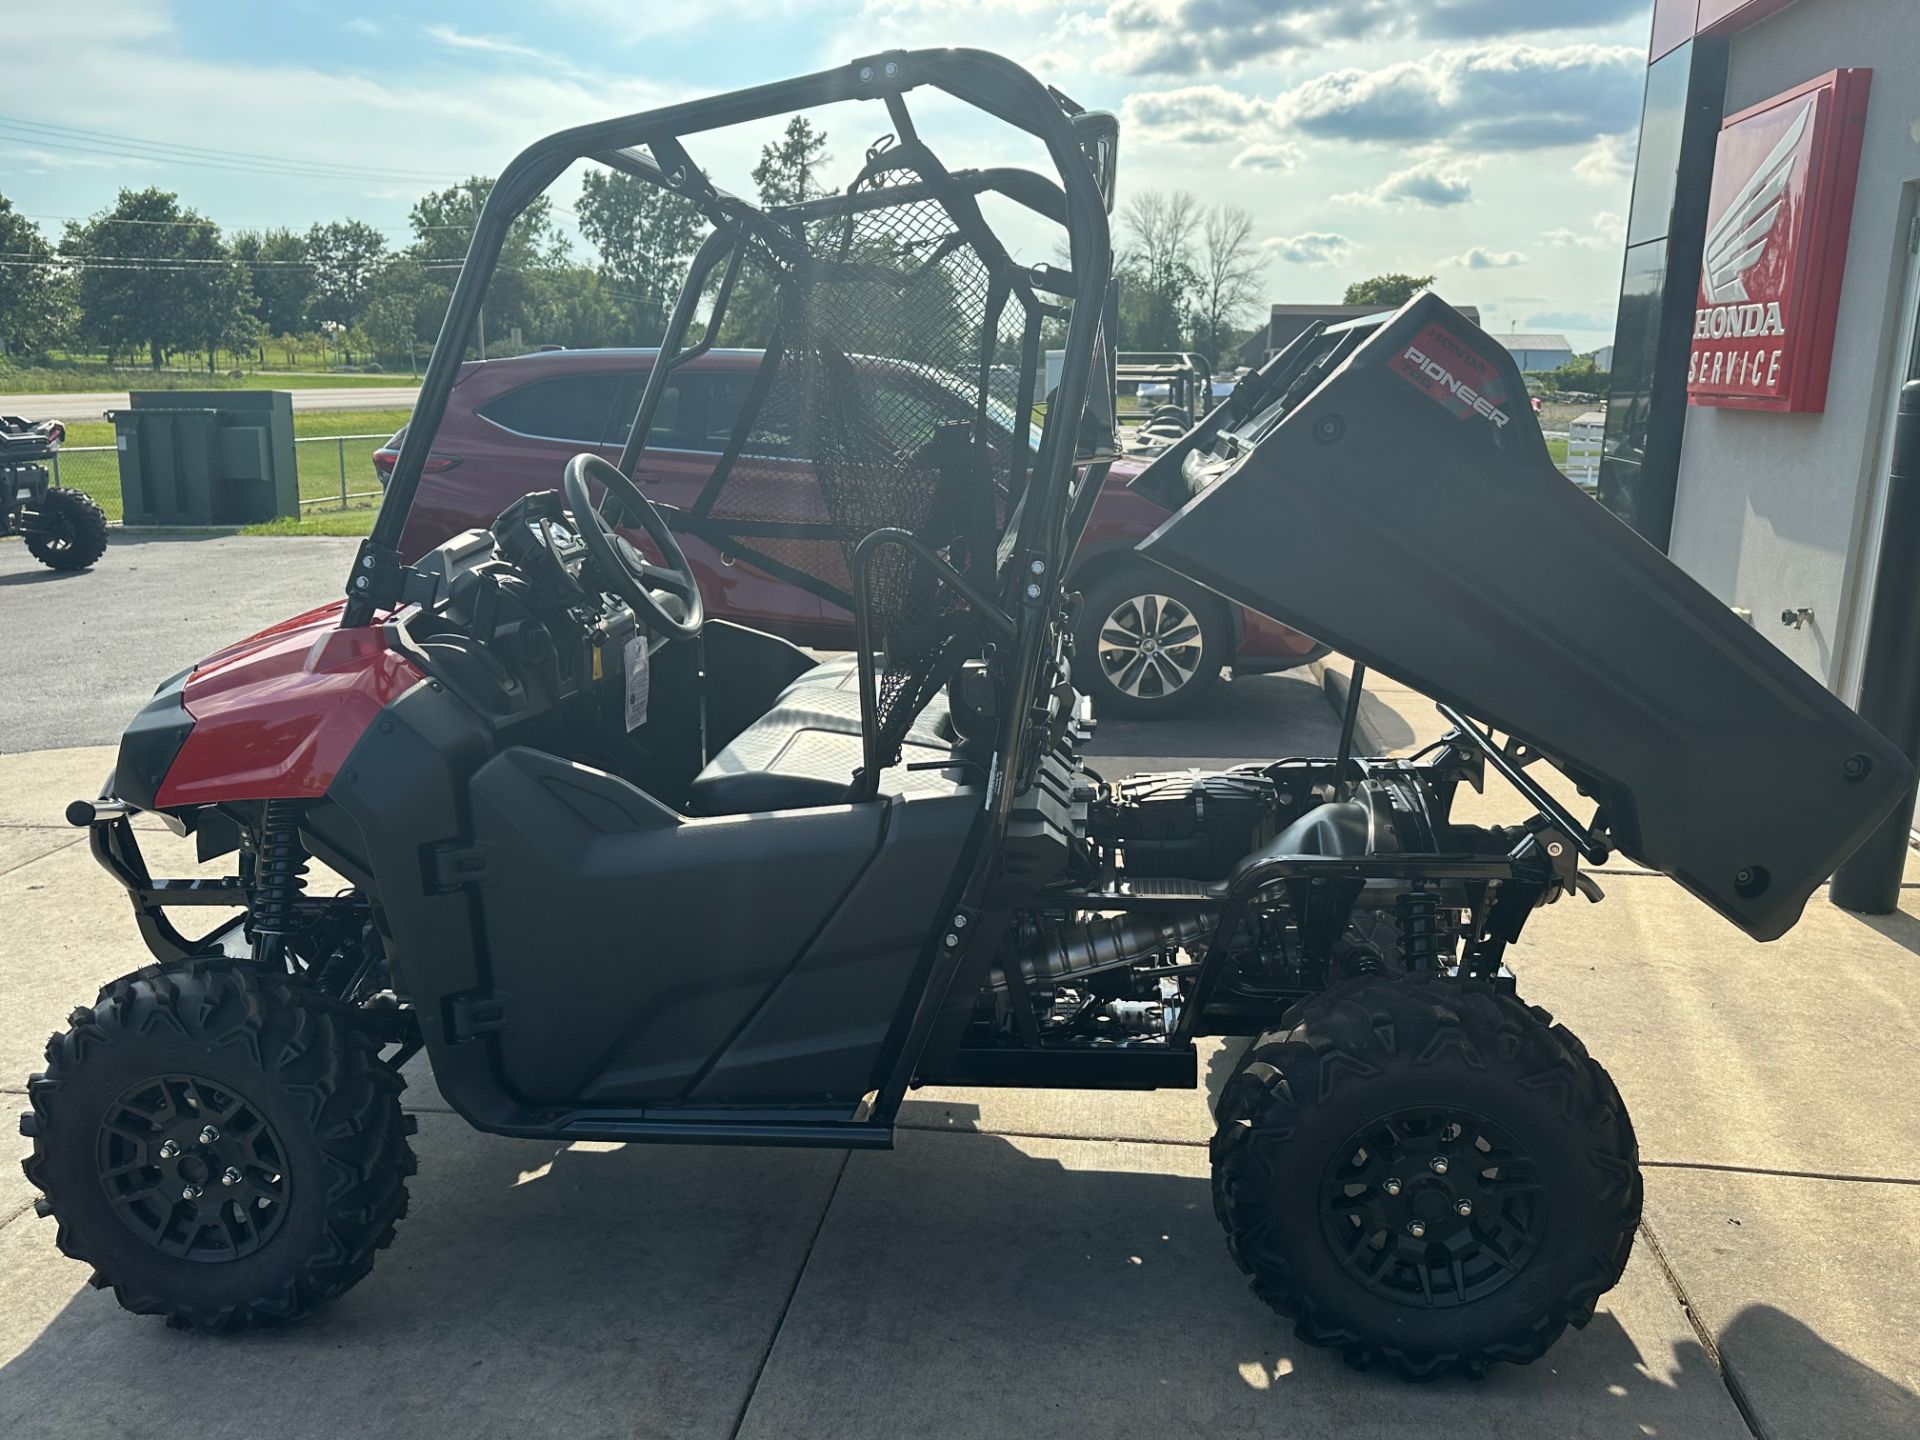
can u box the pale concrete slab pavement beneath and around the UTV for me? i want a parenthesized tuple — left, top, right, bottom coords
(0, 675, 1920, 1440)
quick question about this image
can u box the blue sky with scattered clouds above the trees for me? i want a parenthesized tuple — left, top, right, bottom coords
(0, 0, 1649, 349)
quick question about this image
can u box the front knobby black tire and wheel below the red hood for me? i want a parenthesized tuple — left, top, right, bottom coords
(21, 960, 415, 1331)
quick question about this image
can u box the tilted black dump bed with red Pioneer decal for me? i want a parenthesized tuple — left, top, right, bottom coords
(1140, 294, 1912, 941)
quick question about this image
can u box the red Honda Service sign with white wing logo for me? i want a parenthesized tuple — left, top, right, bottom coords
(1688, 69, 1872, 411)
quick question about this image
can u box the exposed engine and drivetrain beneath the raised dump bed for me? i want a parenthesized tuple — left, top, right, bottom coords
(979, 760, 1467, 1044)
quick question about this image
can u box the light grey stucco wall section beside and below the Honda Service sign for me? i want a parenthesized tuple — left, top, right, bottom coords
(1668, 0, 1920, 691)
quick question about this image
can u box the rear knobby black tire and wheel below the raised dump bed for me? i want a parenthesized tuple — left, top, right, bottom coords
(1213, 975, 1642, 1380)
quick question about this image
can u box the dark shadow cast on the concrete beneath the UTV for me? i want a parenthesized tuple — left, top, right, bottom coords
(0, 1116, 1766, 1440)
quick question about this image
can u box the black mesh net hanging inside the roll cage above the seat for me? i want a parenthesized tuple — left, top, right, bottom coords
(701, 159, 1027, 764)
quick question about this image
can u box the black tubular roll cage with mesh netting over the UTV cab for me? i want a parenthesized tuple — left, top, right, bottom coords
(342, 50, 1117, 1144)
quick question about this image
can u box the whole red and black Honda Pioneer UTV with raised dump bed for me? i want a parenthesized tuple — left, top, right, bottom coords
(23, 50, 1910, 1377)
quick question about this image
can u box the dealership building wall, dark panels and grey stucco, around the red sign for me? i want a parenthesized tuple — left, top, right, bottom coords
(1601, 0, 1920, 701)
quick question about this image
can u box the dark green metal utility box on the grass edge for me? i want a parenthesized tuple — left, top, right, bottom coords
(108, 390, 300, 526)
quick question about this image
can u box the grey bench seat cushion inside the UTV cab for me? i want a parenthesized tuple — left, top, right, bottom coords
(687, 657, 952, 816)
